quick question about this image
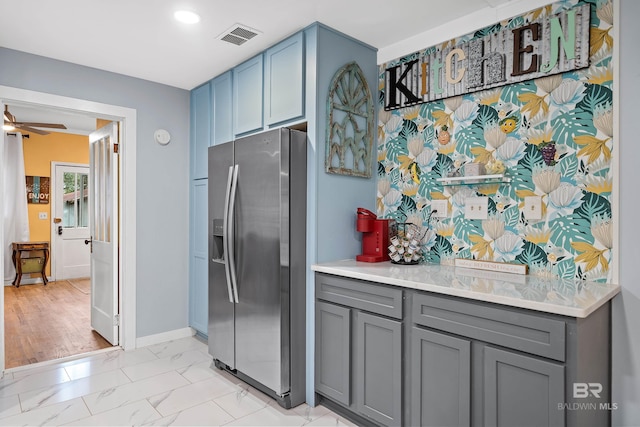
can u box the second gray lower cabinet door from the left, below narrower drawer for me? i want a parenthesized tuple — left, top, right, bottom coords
(355, 312, 402, 425)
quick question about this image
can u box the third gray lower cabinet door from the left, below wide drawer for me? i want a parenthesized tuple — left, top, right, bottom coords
(407, 327, 471, 426)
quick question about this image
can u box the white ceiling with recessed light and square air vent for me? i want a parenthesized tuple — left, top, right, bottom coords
(0, 0, 528, 134)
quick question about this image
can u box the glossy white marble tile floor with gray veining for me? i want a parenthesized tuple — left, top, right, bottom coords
(0, 337, 355, 426)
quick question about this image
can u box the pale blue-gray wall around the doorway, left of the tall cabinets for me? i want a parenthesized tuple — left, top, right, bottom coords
(0, 48, 189, 337)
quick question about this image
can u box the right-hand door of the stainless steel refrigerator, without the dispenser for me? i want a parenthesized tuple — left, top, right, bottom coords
(235, 129, 289, 394)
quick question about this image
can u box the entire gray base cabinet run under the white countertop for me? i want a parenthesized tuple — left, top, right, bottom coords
(315, 273, 611, 427)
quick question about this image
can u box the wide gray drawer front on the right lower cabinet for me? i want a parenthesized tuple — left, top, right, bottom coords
(412, 294, 565, 362)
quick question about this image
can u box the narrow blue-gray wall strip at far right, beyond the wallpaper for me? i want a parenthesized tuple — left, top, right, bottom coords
(612, 0, 640, 426)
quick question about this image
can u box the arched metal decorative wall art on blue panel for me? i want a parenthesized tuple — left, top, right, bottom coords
(325, 62, 374, 178)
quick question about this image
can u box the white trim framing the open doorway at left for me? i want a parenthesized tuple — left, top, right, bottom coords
(0, 85, 137, 373)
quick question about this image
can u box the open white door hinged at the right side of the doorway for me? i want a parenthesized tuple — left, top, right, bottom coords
(89, 123, 118, 345)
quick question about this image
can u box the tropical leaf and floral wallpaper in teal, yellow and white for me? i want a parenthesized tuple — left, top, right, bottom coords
(377, 0, 615, 282)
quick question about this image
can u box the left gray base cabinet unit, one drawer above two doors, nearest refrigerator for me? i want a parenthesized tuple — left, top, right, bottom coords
(315, 275, 402, 425)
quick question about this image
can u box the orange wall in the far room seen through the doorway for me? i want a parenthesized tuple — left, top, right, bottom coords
(23, 132, 89, 274)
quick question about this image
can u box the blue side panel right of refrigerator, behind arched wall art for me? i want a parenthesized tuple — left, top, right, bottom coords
(305, 23, 378, 404)
